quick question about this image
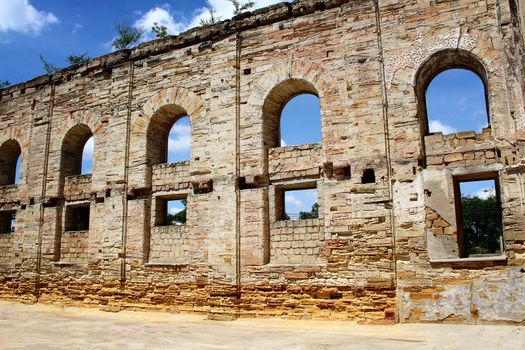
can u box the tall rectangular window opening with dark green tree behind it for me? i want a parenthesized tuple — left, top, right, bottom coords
(454, 177, 503, 258)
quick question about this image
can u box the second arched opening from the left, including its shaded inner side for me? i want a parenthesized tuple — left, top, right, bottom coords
(61, 124, 94, 178)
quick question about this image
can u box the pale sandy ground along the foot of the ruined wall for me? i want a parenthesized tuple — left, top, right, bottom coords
(0, 302, 525, 350)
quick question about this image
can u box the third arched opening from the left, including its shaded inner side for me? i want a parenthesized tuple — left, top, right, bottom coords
(146, 105, 191, 165)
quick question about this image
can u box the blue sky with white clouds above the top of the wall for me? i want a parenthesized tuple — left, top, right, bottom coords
(0, 0, 288, 84)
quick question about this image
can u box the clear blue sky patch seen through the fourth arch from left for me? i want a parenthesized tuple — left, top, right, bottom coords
(279, 93, 321, 147)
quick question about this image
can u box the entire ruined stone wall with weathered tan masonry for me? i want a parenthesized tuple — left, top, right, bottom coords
(0, 0, 525, 323)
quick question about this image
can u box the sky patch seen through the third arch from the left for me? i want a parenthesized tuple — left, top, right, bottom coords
(167, 115, 191, 163)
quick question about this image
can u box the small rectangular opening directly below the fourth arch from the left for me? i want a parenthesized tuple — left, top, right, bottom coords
(280, 188, 319, 220)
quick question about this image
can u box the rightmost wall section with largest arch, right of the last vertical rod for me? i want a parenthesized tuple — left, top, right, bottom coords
(381, 1, 525, 322)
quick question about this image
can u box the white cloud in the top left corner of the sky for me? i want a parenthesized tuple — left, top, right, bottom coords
(0, 0, 58, 34)
